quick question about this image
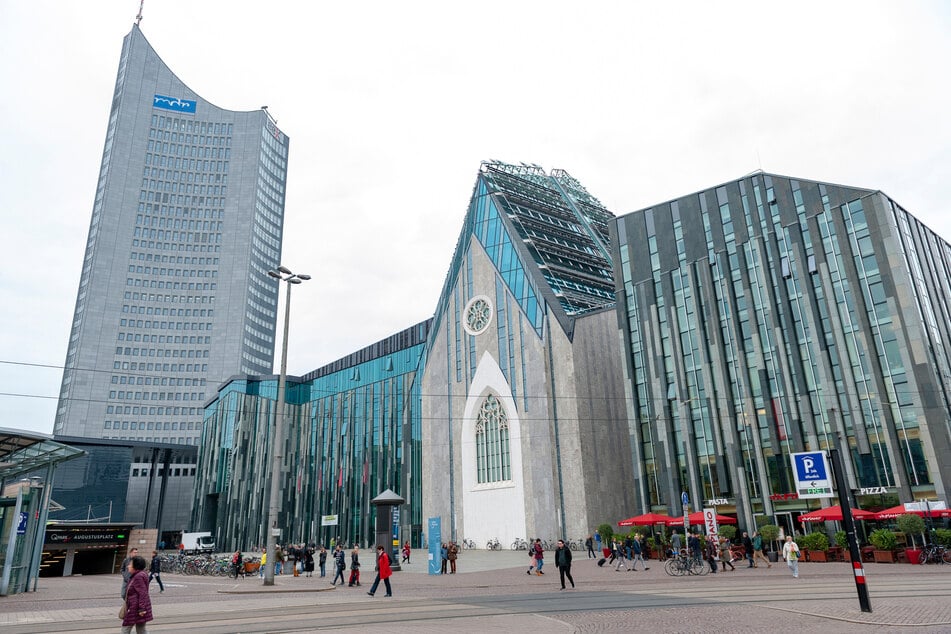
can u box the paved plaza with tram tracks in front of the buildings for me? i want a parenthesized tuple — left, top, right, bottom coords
(0, 550, 951, 634)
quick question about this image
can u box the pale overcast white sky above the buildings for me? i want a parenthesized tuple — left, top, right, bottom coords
(0, 0, 951, 433)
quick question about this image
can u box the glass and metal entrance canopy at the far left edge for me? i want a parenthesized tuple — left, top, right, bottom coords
(0, 427, 86, 596)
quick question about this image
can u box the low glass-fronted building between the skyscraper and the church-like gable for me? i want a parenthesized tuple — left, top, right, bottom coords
(192, 321, 431, 551)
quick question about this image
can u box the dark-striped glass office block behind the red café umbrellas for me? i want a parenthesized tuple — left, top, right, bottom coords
(612, 173, 951, 529)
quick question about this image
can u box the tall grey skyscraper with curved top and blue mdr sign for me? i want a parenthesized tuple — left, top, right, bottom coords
(54, 26, 289, 444)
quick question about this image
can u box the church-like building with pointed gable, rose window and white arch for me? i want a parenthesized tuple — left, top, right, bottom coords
(420, 162, 634, 547)
